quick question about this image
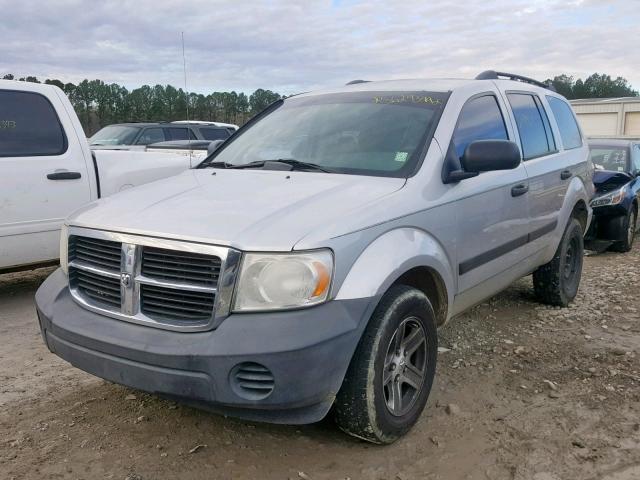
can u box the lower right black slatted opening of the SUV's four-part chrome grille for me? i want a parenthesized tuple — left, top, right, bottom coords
(140, 285, 215, 321)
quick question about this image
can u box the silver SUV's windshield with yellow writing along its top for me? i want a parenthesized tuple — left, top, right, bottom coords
(203, 92, 447, 177)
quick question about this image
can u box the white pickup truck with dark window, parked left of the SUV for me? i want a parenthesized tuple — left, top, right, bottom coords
(0, 80, 203, 273)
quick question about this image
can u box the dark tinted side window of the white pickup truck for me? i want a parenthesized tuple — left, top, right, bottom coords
(0, 90, 67, 157)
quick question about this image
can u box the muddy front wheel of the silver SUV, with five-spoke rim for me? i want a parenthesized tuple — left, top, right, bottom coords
(334, 285, 438, 444)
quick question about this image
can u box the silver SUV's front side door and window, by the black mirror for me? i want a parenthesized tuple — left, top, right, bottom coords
(450, 92, 529, 313)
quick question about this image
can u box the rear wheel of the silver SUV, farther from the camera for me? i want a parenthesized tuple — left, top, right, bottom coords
(533, 218, 584, 307)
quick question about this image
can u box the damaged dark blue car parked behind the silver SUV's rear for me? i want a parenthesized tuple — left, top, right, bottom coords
(585, 138, 640, 252)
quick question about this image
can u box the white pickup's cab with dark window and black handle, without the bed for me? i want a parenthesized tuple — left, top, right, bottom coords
(0, 82, 93, 270)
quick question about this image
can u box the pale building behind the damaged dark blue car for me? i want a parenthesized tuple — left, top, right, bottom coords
(571, 97, 640, 138)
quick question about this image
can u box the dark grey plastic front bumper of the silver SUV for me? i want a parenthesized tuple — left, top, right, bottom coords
(36, 270, 377, 424)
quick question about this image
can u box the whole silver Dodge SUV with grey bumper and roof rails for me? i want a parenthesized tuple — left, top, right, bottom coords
(36, 71, 593, 443)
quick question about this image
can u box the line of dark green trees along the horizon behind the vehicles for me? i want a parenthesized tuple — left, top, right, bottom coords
(3, 73, 638, 136)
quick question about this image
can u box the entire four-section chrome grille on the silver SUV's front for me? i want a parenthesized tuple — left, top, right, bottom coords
(69, 227, 240, 331)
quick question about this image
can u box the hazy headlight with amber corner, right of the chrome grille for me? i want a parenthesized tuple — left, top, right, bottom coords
(233, 250, 333, 312)
